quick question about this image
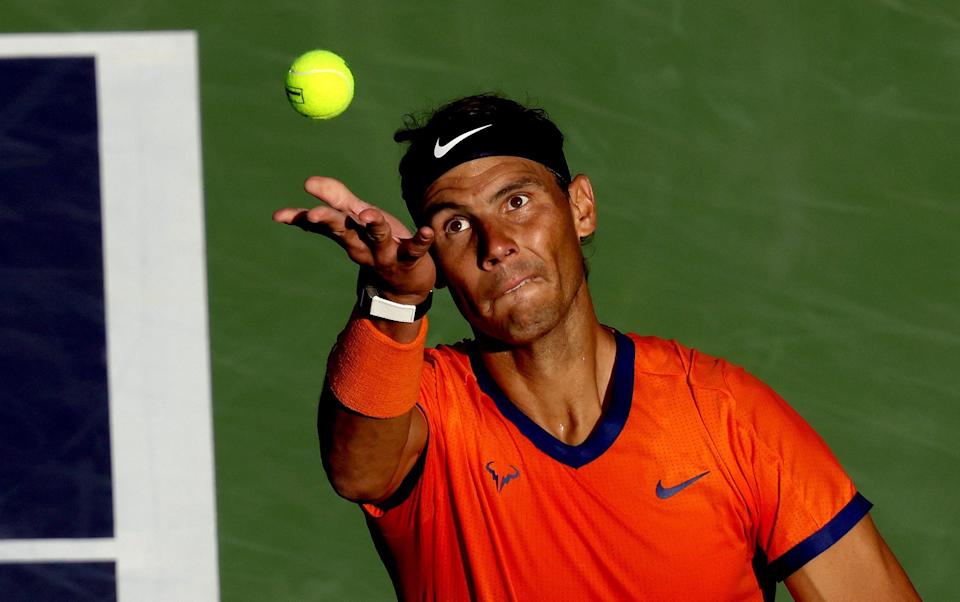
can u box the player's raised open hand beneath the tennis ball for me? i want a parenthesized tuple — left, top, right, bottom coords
(273, 176, 437, 304)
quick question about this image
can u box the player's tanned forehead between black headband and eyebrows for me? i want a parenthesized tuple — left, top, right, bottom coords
(423, 156, 556, 210)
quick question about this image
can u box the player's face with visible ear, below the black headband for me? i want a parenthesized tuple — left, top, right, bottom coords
(421, 156, 595, 344)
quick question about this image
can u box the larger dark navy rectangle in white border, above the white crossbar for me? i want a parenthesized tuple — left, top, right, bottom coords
(0, 57, 113, 540)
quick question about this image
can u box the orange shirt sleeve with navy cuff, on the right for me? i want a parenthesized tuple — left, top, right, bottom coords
(718, 360, 871, 581)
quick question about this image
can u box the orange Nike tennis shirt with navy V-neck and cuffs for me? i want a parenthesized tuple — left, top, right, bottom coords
(352, 326, 870, 601)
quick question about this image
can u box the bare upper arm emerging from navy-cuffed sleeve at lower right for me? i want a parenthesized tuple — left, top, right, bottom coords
(785, 514, 920, 602)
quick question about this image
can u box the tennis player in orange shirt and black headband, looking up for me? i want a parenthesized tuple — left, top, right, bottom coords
(274, 95, 917, 601)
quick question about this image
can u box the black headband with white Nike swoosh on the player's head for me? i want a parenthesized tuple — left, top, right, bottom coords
(400, 116, 570, 209)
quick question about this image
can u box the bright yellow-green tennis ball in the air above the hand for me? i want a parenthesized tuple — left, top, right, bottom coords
(286, 50, 353, 119)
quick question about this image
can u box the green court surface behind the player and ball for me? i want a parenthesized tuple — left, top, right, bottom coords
(0, 0, 960, 601)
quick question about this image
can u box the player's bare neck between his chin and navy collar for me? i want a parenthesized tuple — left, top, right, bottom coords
(480, 285, 616, 445)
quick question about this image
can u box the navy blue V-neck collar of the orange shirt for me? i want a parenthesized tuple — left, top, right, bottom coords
(470, 331, 634, 468)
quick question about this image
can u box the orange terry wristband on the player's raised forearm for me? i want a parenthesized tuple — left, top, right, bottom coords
(327, 318, 427, 418)
